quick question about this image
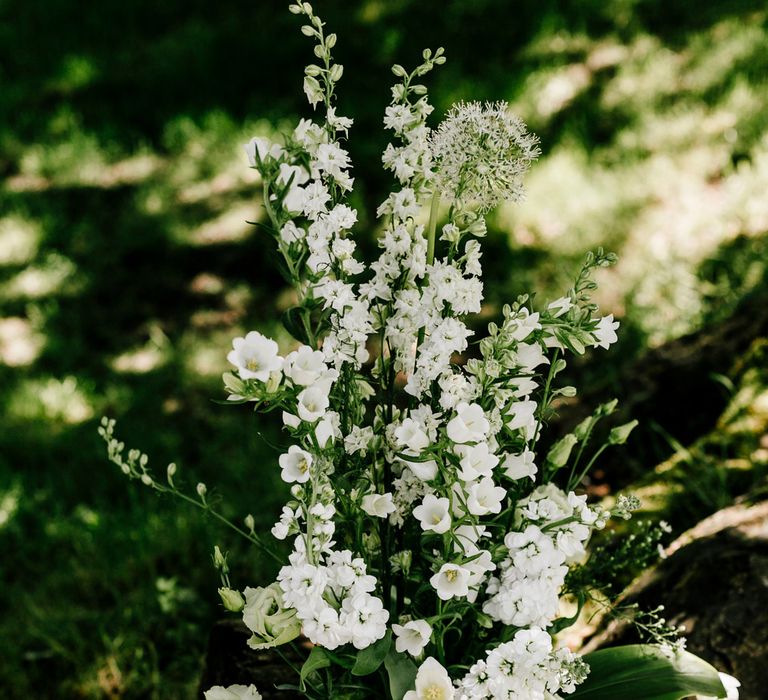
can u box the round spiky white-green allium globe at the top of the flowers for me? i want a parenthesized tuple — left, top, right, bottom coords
(429, 102, 540, 212)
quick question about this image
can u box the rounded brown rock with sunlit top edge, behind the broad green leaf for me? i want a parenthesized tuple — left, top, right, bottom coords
(587, 501, 768, 700)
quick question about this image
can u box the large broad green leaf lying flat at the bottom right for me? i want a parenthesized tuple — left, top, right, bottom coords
(568, 644, 726, 700)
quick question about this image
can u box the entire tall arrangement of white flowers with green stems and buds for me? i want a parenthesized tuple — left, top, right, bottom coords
(101, 3, 737, 700)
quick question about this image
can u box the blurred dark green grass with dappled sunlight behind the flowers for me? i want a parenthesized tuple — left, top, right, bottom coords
(0, 0, 768, 698)
